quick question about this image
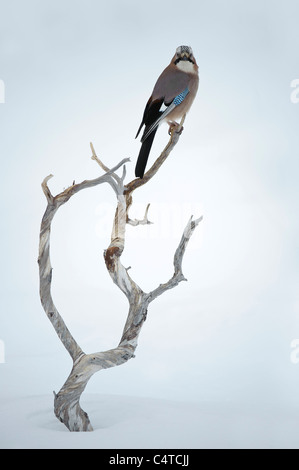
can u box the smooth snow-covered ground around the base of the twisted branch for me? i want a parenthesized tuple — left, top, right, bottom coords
(0, 394, 299, 449)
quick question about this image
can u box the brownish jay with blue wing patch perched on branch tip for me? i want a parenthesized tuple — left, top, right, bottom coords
(135, 46, 199, 178)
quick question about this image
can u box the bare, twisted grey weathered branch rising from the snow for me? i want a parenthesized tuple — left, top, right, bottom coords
(38, 122, 201, 431)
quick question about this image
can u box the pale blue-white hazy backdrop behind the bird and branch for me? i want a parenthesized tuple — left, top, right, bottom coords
(0, 0, 299, 447)
